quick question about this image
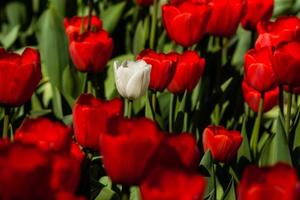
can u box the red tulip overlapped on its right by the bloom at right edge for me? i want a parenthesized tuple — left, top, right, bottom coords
(244, 47, 277, 92)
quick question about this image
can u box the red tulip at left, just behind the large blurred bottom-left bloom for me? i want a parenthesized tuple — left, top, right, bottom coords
(15, 117, 71, 153)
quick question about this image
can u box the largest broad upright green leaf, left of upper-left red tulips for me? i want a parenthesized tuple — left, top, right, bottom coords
(37, 8, 69, 91)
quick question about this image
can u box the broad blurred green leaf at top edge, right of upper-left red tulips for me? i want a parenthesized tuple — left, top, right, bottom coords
(100, 1, 126, 33)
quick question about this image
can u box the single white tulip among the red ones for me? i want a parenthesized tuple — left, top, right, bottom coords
(114, 60, 151, 100)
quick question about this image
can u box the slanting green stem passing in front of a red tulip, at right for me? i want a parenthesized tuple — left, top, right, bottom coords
(250, 93, 264, 159)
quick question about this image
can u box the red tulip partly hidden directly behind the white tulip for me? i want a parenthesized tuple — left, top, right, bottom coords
(137, 49, 177, 91)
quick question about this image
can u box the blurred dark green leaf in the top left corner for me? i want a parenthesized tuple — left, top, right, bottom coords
(5, 2, 27, 26)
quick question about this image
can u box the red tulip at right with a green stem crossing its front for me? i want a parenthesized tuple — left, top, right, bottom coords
(242, 80, 279, 113)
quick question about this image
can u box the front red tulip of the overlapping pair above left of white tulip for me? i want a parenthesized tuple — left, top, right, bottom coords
(69, 30, 113, 73)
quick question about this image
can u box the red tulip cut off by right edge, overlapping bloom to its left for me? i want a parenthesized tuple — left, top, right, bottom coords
(273, 42, 300, 87)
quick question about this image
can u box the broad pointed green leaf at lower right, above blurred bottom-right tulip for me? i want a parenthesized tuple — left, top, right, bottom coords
(260, 116, 291, 166)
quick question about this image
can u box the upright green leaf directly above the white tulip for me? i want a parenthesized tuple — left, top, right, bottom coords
(133, 21, 146, 55)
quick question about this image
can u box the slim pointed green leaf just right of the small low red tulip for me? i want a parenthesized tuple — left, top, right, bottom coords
(237, 117, 252, 162)
